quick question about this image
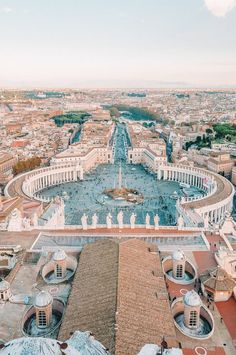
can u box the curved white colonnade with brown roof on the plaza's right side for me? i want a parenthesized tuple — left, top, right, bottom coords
(157, 164, 235, 224)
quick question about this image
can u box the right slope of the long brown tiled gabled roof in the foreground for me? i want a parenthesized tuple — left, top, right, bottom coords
(115, 239, 176, 355)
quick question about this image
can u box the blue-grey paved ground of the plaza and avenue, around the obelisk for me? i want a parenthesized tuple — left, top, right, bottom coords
(40, 125, 203, 225)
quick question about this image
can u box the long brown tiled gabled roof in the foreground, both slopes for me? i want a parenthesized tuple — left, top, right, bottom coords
(59, 239, 177, 355)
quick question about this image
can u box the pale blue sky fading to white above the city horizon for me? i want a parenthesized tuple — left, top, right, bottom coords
(0, 0, 236, 87)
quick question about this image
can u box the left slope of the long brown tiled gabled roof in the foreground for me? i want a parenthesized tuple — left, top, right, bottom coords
(59, 240, 119, 353)
